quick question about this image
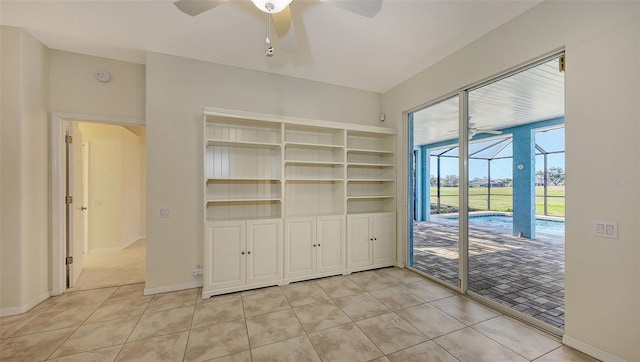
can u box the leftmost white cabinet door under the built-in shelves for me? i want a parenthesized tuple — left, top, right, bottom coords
(203, 221, 246, 290)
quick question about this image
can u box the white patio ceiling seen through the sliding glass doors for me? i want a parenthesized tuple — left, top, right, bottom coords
(413, 58, 564, 145)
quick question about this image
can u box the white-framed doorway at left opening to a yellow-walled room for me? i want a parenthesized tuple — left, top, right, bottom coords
(51, 113, 146, 295)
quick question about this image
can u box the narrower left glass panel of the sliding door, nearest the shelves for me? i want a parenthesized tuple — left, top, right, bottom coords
(409, 96, 460, 287)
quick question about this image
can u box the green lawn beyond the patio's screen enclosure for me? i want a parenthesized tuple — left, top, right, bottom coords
(431, 186, 564, 216)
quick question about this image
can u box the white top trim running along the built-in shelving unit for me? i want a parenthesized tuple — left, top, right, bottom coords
(202, 107, 398, 136)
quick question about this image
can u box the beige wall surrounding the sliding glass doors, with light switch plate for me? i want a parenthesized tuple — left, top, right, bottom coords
(383, 2, 640, 361)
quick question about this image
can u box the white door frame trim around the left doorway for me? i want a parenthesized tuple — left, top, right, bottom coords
(51, 112, 147, 296)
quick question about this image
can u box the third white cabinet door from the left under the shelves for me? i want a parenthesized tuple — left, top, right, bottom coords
(284, 217, 316, 278)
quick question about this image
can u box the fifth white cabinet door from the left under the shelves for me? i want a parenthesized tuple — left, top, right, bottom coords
(347, 214, 373, 268)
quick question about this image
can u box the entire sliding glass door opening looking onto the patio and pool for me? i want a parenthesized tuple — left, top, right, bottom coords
(408, 54, 565, 334)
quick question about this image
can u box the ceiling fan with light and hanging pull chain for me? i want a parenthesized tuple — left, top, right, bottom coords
(173, 0, 382, 57)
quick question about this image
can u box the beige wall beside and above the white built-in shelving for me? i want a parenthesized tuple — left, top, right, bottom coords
(146, 53, 381, 290)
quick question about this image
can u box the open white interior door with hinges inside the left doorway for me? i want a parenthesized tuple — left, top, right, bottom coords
(67, 122, 85, 288)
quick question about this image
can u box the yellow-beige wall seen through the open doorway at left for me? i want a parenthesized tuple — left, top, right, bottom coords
(80, 122, 144, 252)
